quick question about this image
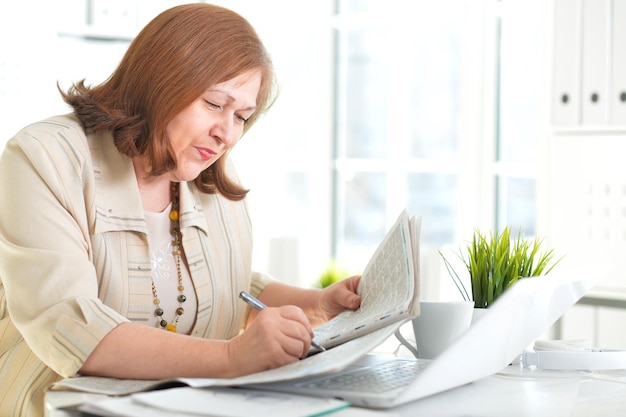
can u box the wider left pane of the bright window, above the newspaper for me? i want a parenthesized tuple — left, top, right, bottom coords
(334, 0, 465, 265)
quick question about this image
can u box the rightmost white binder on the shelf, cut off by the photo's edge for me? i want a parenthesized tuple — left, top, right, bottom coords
(610, 0, 626, 125)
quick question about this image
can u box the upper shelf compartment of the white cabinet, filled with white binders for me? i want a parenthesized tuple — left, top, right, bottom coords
(551, 0, 626, 128)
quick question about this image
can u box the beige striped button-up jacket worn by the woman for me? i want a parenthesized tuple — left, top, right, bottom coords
(0, 115, 270, 417)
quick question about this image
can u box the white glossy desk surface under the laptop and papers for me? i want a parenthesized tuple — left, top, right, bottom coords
(46, 365, 626, 417)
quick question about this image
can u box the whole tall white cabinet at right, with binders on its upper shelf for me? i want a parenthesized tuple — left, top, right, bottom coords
(546, 0, 626, 349)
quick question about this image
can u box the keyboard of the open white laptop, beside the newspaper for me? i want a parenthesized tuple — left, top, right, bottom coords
(297, 360, 428, 392)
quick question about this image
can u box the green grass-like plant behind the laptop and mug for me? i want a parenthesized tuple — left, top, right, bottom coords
(439, 226, 560, 308)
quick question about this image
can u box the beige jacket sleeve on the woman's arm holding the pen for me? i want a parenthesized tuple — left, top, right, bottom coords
(0, 123, 127, 376)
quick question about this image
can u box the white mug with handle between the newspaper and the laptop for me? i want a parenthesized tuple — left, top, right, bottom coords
(395, 301, 474, 359)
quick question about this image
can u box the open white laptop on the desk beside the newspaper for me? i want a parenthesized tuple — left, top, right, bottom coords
(250, 267, 608, 409)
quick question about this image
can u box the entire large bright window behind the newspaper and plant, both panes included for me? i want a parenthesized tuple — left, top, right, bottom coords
(333, 0, 545, 272)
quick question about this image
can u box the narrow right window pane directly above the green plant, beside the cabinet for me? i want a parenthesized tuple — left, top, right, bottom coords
(494, 0, 549, 236)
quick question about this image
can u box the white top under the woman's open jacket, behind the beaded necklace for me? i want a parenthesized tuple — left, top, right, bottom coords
(144, 203, 198, 334)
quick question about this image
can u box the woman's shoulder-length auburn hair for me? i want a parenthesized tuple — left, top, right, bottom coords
(61, 3, 275, 200)
